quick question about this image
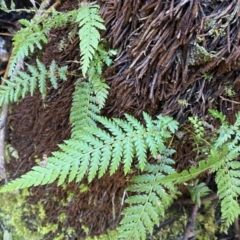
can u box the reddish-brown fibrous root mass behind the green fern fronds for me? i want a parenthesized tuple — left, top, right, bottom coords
(2, 0, 240, 239)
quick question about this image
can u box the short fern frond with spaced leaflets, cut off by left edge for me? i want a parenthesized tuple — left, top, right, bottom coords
(0, 60, 67, 105)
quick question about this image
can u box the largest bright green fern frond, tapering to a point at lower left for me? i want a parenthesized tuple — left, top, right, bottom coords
(1, 113, 178, 192)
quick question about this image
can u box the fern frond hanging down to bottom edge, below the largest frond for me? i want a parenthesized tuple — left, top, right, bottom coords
(118, 150, 177, 239)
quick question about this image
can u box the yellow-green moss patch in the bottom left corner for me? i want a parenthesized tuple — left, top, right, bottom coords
(0, 189, 75, 240)
